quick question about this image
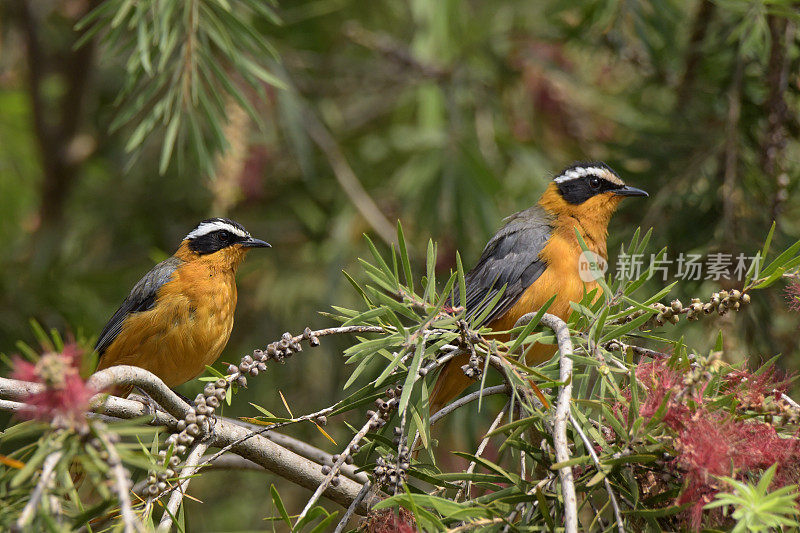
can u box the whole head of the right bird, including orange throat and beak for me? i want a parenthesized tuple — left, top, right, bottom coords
(539, 162, 648, 224)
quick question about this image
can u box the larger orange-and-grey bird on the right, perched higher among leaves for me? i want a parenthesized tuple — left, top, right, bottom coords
(430, 162, 647, 413)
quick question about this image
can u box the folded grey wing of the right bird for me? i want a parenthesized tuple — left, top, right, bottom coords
(464, 206, 553, 326)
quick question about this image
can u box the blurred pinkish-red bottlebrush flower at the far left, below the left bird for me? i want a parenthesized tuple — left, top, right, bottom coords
(12, 344, 96, 424)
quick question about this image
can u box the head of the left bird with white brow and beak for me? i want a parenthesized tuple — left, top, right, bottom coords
(175, 218, 271, 268)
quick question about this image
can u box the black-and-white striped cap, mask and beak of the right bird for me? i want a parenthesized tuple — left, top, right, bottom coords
(553, 161, 647, 205)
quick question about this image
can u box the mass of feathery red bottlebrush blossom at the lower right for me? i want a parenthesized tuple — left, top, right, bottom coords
(632, 354, 800, 530)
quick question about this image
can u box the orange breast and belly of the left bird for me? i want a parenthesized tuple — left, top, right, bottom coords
(98, 259, 237, 387)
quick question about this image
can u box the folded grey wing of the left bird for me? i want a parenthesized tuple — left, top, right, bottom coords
(94, 257, 181, 358)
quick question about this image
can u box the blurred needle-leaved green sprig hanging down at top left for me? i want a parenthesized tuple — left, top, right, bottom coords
(76, 0, 283, 174)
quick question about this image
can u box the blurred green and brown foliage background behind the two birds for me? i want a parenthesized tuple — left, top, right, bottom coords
(0, 0, 800, 530)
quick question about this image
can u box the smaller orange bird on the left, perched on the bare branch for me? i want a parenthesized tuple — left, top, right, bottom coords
(95, 218, 270, 395)
